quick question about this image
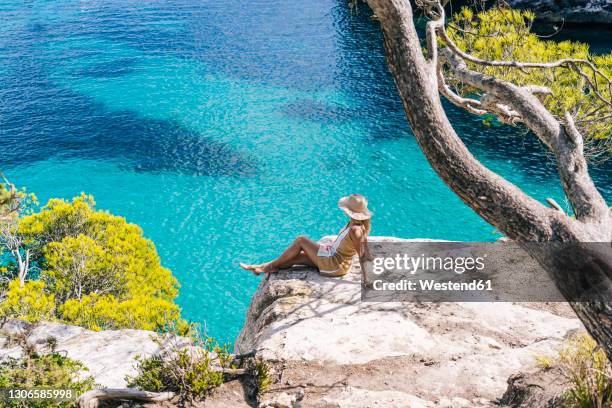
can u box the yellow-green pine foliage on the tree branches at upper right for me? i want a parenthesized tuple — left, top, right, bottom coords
(445, 7, 612, 158)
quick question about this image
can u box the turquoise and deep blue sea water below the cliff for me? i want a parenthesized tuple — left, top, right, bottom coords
(0, 0, 612, 340)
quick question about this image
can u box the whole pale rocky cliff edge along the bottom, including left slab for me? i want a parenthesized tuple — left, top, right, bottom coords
(0, 237, 582, 408)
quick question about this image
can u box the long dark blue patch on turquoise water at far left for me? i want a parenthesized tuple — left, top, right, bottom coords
(0, 72, 256, 176)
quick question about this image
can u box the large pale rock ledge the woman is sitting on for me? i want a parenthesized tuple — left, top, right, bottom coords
(235, 238, 581, 408)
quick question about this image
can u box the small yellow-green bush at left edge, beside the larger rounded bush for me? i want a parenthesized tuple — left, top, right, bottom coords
(0, 279, 55, 322)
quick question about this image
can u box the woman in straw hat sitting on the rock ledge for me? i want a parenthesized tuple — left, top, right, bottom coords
(240, 194, 372, 276)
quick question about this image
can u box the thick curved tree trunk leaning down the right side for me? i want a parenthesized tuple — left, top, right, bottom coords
(367, 0, 612, 361)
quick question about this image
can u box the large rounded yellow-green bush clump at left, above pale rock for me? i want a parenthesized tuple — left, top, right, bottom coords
(0, 185, 189, 333)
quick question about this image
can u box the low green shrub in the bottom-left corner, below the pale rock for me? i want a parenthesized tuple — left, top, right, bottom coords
(0, 331, 95, 408)
